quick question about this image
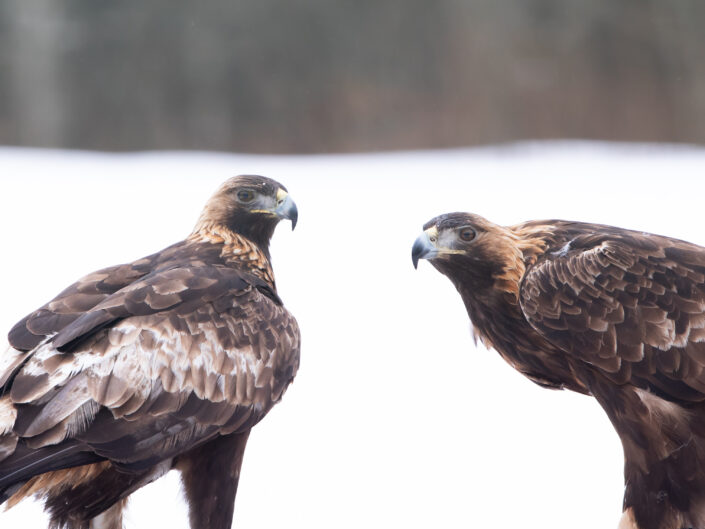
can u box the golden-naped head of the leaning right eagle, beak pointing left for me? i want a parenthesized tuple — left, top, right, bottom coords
(411, 213, 526, 297)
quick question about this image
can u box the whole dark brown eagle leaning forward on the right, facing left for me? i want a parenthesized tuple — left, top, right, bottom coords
(412, 213, 705, 529)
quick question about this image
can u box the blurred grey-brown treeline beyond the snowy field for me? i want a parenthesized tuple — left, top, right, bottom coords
(0, 0, 705, 152)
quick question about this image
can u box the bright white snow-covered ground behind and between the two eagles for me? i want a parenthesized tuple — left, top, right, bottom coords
(0, 143, 705, 529)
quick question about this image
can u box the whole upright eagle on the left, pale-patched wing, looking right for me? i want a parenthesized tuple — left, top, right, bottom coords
(0, 176, 300, 529)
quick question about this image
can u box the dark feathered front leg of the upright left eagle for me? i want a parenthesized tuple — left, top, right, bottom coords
(175, 431, 250, 529)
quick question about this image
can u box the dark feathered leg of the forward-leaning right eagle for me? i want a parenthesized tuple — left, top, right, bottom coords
(588, 377, 705, 529)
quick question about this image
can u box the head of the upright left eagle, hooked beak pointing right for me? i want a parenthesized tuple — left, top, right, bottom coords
(194, 175, 298, 247)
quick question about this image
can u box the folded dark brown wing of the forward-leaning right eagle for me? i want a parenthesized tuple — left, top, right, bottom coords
(520, 230, 705, 402)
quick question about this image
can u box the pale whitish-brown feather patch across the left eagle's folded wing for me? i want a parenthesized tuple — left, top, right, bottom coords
(11, 290, 298, 446)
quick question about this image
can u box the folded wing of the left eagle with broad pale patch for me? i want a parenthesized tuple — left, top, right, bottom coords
(0, 263, 299, 478)
